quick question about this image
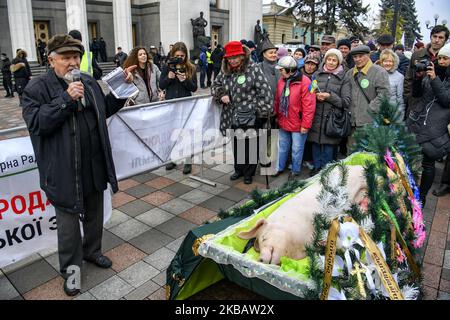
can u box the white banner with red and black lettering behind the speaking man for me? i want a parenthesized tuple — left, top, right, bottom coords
(0, 137, 112, 268)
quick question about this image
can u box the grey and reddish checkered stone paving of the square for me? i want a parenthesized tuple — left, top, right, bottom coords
(0, 85, 450, 300)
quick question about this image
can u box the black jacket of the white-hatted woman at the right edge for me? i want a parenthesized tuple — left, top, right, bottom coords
(406, 67, 450, 152)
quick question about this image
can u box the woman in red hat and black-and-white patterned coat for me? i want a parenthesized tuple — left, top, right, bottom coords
(211, 41, 273, 184)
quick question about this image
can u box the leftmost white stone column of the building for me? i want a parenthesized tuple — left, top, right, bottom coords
(7, 0, 37, 62)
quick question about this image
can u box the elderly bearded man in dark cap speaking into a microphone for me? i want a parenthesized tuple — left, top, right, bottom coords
(23, 35, 136, 296)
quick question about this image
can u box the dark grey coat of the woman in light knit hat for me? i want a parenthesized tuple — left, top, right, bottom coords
(308, 65, 351, 144)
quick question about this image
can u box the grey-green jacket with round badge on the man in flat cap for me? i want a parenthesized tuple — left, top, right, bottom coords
(347, 61, 389, 127)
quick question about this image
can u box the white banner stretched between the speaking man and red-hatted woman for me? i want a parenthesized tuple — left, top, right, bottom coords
(108, 96, 220, 179)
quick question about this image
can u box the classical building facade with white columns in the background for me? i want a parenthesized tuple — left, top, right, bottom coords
(0, 0, 262, 61)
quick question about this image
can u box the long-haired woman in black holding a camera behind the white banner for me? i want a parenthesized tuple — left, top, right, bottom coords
(159, 42, 197, 174)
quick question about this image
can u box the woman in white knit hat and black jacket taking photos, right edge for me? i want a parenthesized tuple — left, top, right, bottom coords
(407, 44, 450, 206)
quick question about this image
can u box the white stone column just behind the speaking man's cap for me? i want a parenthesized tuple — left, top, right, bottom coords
(66, 0, 90, 51)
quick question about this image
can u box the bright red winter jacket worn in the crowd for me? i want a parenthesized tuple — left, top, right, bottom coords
(274, 73, 316, 132)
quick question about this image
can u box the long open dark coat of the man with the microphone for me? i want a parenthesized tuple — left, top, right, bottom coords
(23, 70, 126, 213)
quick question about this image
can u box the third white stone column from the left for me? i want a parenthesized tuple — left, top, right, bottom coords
(113, 0, 133, 52)
